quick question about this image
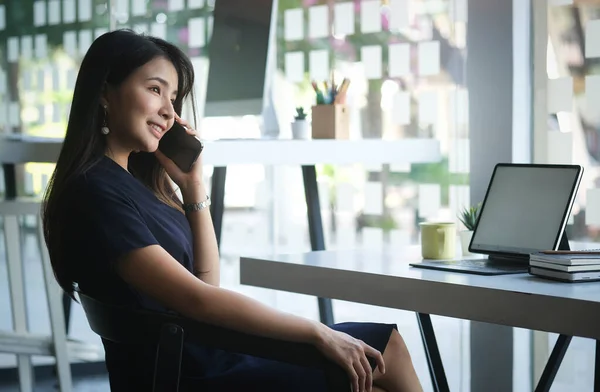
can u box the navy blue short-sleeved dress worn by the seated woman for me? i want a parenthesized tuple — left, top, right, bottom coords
(63, 157, 396, 392)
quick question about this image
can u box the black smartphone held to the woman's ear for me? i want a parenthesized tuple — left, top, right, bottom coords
(158, 121, 204, 173)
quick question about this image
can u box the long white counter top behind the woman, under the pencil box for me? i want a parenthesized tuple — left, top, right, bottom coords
(0, 136, 441, 166)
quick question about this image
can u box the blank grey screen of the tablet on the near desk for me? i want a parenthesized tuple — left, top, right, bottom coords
(471, 166, 579, 253)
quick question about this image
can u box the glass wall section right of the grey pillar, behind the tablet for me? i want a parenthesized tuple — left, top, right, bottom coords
(532, 0, 600, 391)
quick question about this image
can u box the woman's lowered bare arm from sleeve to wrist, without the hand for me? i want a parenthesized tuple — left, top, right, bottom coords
(117, 247, 323, 344)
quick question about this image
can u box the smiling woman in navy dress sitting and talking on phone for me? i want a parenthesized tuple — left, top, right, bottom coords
(43, 30, 421, 391)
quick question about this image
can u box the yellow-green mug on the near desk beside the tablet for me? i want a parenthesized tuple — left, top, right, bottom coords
(420, 222, 456, 259)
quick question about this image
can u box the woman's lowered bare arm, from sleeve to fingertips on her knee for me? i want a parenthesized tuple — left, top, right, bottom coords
(117, 245, 385, 392)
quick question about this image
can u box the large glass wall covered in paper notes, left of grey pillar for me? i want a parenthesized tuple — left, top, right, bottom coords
(0, 0, 478, 390)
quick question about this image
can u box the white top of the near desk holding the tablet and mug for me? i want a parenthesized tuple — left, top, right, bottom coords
(240, 246, 600, 339)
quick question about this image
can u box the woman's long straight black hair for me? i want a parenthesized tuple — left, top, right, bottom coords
(42, 30, 195, 296)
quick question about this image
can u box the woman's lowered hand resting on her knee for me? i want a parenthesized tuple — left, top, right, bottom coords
(317, 326, 385, 392)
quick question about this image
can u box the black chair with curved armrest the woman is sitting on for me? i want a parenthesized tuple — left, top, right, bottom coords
(77, 289, 351, 392)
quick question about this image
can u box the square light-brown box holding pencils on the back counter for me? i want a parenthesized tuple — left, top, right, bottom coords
(312, 104, 350, 140)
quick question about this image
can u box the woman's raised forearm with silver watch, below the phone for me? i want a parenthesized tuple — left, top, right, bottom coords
(182, 185, 221, 287)
